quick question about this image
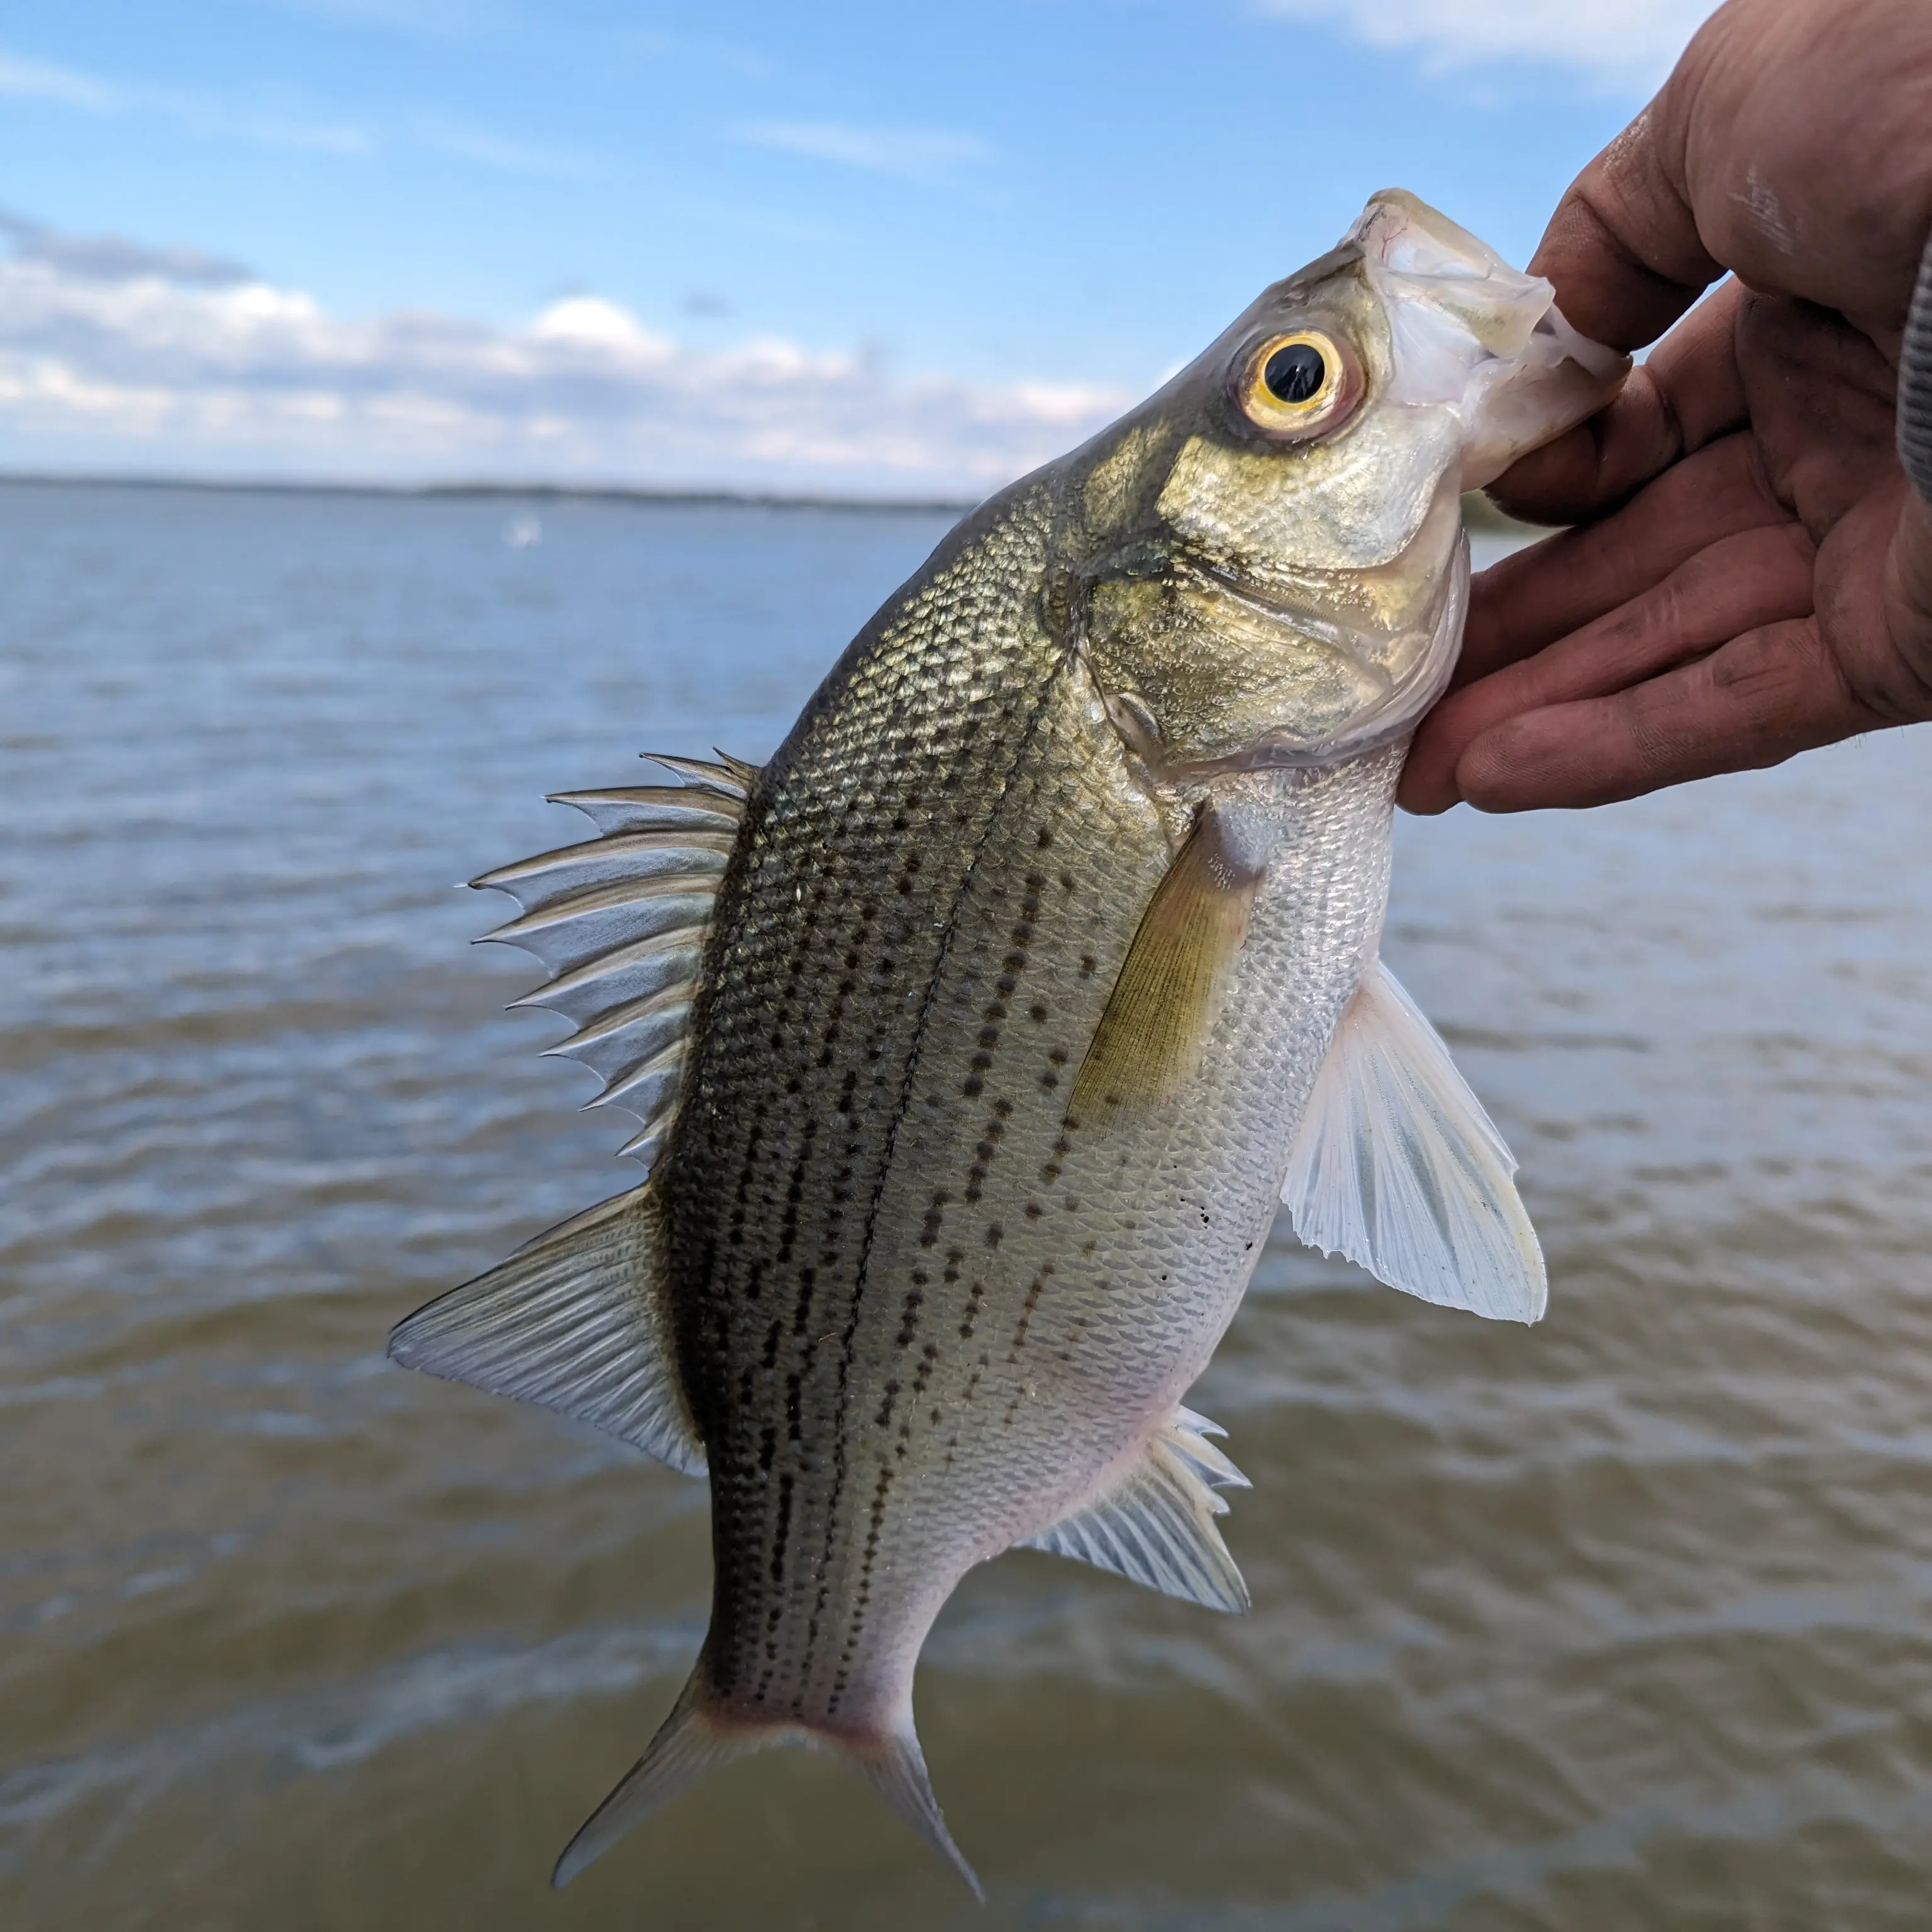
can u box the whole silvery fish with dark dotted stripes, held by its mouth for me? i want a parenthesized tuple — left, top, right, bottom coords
(391, 189, 1629, 1894)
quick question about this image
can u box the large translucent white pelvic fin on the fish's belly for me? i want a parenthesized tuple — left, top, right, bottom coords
(1281, 960, 1548, 1321)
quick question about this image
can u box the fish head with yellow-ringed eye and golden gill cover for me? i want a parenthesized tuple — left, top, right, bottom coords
(1049, 189, 1631, 779)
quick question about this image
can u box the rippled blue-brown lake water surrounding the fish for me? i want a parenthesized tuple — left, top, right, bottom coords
(0, 487, 1932, 1932)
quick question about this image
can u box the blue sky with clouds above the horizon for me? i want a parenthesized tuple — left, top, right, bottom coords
(0, 0, 1710, 499)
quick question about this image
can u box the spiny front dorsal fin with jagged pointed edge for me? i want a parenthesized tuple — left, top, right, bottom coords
(469, 753, 757, 1167)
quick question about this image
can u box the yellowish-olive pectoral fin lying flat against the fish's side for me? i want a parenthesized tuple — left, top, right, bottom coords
(1069, 806, 1267, 1124)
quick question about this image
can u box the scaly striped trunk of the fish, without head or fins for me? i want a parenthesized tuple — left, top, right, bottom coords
(661, 498, 1399, 1739)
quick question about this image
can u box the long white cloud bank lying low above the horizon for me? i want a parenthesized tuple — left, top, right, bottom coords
(0, 216, 1132, 494)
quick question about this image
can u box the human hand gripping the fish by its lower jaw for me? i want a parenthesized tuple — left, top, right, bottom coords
(1401, 0, 1932, 811)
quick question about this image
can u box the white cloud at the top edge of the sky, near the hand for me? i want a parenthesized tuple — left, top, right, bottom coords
(1258, 0, 1718, 89)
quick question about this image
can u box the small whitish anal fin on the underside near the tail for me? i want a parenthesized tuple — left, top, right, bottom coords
(1020, 1408, 1248, 1611)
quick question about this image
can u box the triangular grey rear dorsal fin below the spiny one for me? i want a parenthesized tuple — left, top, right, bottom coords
(388, 1182, 705, 1476)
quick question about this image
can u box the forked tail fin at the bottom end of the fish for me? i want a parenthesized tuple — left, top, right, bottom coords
(551, 1662, 985, 1905)
